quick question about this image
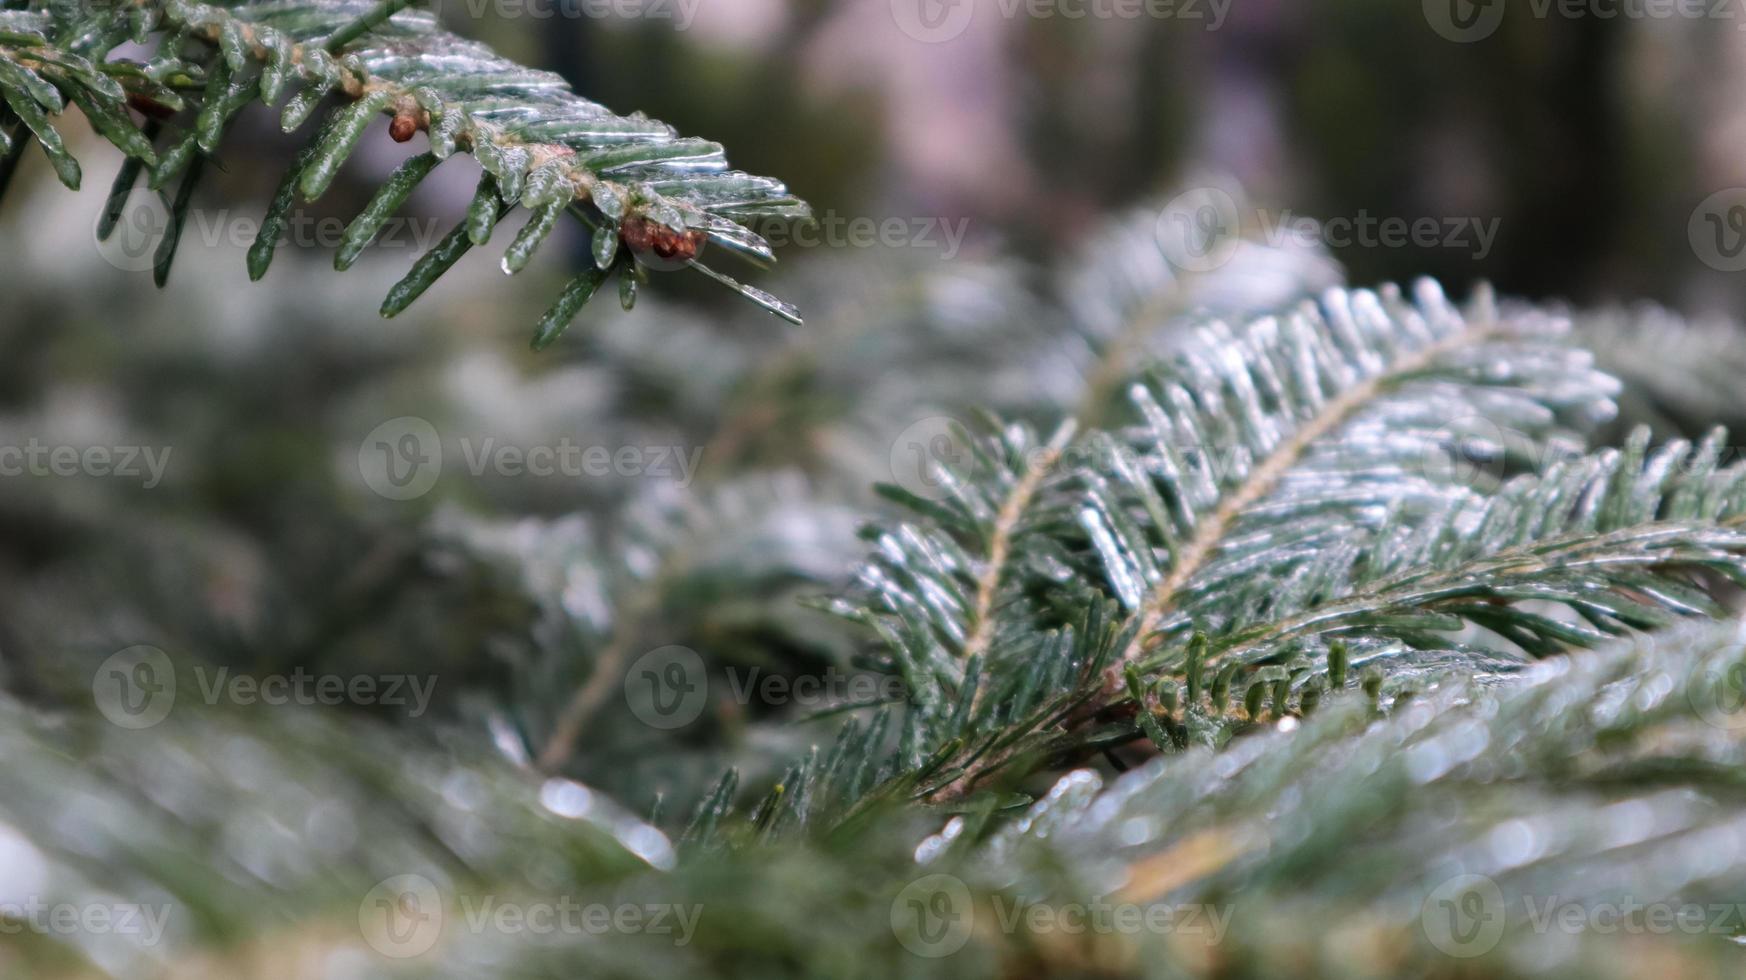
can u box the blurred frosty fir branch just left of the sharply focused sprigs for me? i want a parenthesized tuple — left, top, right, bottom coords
(433, 479, 854, 805)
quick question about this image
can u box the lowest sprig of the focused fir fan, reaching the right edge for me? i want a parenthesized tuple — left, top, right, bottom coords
(1173, 443, 1746, 681)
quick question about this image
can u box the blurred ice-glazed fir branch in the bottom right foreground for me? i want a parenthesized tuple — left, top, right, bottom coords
(970, 620, 1746, 977)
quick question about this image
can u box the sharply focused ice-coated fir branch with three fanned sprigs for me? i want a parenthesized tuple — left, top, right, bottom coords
(833, 276, 1746, 800)
